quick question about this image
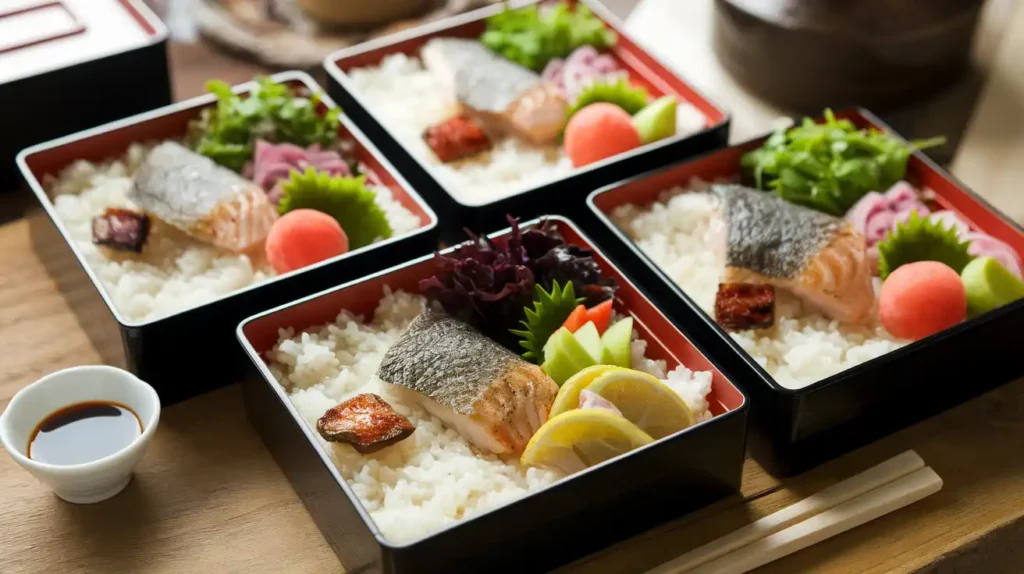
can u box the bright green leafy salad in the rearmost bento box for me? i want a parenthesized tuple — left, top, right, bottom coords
(480, 0, 617, 72)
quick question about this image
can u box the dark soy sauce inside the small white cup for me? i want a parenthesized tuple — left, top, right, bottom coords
(27, 401, 142, 466)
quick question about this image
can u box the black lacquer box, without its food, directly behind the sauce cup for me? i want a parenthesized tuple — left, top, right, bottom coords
(17, 72, 437, 405)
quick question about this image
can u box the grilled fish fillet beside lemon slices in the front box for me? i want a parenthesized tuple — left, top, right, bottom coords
(377, 309, 558, 454)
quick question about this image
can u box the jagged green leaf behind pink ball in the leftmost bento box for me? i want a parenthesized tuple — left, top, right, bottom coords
(278, 168, 391, 249)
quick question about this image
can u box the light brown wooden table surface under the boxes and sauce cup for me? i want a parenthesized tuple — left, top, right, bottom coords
(0, 2, 1024, 574)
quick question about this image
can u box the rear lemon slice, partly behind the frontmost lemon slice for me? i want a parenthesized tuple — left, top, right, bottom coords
(587, 369, 696, 439)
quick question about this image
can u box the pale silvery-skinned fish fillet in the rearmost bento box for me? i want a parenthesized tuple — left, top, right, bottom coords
(420, 38, 568, 144)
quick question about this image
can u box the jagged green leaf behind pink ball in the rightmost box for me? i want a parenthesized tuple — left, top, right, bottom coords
(879, 212, 974, 279)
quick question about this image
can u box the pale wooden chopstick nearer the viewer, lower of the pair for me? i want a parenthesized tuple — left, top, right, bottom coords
(675, 467, 942, 574)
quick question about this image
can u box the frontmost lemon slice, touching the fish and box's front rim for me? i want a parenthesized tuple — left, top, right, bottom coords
(520, 408, 654, 474)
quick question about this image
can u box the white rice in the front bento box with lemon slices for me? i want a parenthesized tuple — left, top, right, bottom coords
(267, 288, 712, 543)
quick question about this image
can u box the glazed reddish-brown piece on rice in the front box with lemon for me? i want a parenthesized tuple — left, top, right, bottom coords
(316, 393, 416, 454)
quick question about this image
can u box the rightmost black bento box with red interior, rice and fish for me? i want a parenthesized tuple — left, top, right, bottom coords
(588, 109, 1024, 476)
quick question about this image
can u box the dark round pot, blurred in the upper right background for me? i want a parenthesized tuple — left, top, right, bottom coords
(712, 0, 985, 114)
